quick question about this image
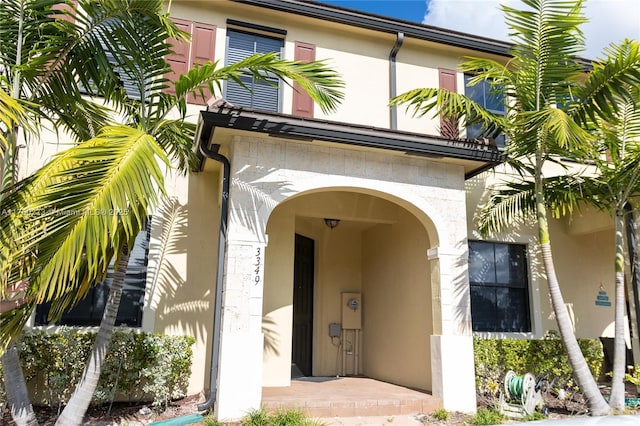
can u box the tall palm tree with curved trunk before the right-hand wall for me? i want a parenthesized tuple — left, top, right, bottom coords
(392, 0, 640, 415)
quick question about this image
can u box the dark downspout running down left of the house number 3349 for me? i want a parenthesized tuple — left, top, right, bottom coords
(198, 124, 231, 411)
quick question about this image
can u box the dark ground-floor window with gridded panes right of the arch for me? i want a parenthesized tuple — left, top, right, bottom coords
(469, 241, 531, 332)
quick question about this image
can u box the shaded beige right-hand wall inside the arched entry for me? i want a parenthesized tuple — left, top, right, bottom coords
(362, 209, 433, 389)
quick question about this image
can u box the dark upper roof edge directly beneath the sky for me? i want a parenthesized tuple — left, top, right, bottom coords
(233, 0, 512, 57)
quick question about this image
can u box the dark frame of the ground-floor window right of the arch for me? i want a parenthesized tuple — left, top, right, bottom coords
(468, 239, 539, 337)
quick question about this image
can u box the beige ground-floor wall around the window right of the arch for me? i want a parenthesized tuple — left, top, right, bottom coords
(466, 164, 615, 344)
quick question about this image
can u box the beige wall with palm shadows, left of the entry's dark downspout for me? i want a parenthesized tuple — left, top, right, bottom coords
(142, 168, 220, 394)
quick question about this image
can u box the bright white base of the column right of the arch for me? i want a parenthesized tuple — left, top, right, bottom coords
(431, 335, 476, 413)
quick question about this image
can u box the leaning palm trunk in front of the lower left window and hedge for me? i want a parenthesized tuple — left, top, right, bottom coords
(56, 243, 129, 426)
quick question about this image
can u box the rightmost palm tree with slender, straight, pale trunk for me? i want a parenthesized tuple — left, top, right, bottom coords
(478, 68, 640, 411)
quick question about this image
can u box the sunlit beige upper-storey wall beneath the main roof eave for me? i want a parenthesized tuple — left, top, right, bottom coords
(166, 1, 504, 135)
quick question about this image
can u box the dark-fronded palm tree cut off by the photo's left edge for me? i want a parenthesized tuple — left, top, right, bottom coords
(0, 0, 188, 425)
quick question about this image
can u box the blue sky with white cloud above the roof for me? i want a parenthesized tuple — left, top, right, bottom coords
(320, 0, 640, 59)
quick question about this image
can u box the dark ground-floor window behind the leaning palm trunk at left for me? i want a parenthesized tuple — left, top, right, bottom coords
(35, 219, 151, 327)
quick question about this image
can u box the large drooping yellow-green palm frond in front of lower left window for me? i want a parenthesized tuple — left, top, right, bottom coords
(0, 126, 168, 303)
